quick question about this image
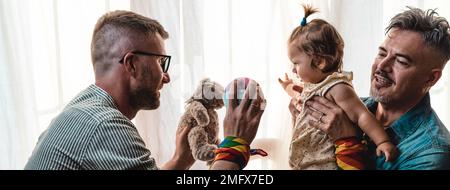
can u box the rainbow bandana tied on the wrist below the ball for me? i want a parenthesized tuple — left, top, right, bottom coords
(214, 136, 267, 170)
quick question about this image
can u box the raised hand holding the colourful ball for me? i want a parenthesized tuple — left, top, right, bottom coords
(223, 80, 266, 144)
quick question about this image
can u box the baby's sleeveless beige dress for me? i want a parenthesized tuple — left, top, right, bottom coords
(289, 72, 352, 170)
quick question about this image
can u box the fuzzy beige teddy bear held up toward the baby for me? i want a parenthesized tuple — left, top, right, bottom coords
(178, 78, 224, 165)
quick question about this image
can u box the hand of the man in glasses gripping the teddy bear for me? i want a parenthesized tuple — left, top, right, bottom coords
(161, 126, 195, 170)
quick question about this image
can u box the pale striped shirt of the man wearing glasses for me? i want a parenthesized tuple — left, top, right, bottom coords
(25, 85, 158, 170)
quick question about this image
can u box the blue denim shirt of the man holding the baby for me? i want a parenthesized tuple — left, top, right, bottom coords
(362, 94, 450, 170)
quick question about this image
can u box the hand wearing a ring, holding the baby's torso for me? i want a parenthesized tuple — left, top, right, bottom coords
(304, 96, 358, 141)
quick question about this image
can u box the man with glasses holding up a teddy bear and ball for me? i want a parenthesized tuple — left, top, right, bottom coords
(25, 11, 263, 170)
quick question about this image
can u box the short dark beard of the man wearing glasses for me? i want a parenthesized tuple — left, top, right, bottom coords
(130, 87, 160, 110)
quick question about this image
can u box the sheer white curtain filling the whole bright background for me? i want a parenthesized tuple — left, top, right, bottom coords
(0, 0, 450, 169)
